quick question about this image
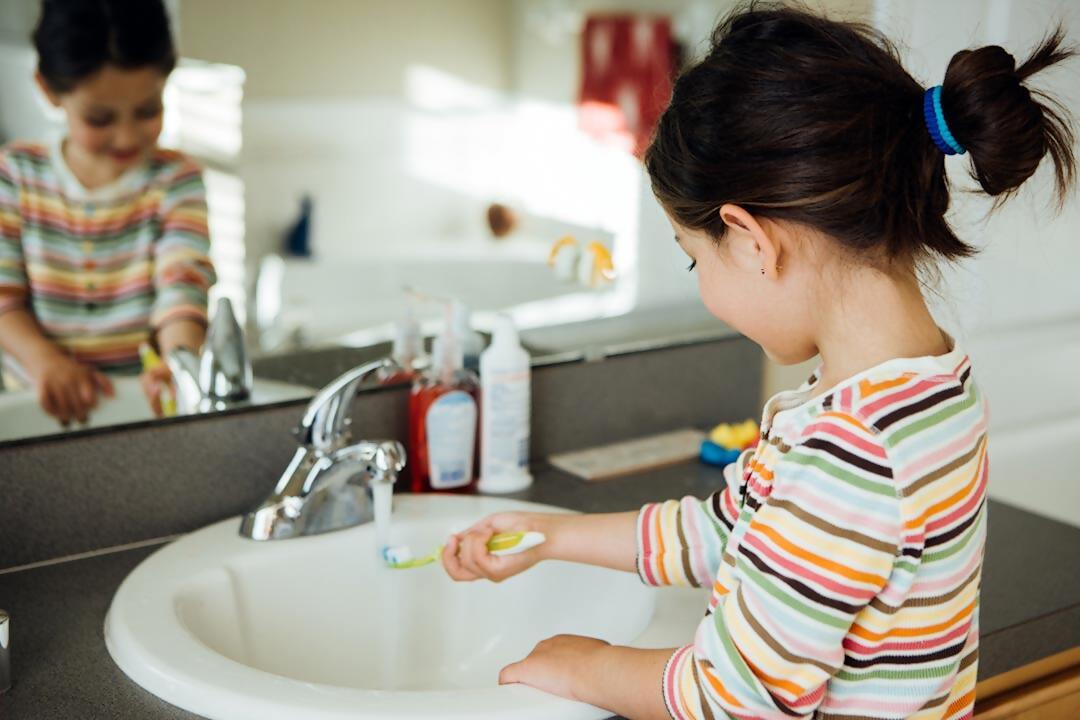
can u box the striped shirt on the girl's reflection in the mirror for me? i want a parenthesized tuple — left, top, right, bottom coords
(0, 142, 215, 372)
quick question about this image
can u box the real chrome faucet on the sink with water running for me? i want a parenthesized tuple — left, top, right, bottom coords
(240, 359, 405, 540)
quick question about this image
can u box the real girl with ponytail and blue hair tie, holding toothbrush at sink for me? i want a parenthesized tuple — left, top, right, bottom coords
(443, 8, 1074, 720)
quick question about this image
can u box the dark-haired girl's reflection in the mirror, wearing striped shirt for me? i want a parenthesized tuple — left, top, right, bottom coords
(0, 0, 215, 423)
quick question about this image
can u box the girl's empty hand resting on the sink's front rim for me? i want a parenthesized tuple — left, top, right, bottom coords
(499, 635, 611, 702)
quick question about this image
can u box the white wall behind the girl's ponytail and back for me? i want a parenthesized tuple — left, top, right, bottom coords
(878, 0, 1080, 525)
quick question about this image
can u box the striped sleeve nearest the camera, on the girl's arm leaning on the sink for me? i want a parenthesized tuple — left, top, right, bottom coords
(663, 412, 902, 720)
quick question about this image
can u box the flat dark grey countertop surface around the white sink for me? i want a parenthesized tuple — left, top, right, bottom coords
(0, 463, 1080, 720)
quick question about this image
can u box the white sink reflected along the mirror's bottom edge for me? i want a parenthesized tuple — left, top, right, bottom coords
(0, 377, 314, 441)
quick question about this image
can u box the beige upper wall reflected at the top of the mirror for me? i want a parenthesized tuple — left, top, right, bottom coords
(180, 0, 509, 99)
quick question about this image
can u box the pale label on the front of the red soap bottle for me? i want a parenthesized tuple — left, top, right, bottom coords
(424, 391, 476, 490)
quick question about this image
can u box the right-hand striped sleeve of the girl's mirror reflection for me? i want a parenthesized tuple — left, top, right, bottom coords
(150, 163, 217, 328)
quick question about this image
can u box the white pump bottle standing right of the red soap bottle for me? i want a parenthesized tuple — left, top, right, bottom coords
(477, 315, 532, 493)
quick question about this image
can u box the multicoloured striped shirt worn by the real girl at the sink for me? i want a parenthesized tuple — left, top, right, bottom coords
(637, 350, 987, 720)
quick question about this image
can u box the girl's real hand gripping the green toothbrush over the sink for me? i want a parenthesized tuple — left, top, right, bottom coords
(443, 513, 558, 583)
